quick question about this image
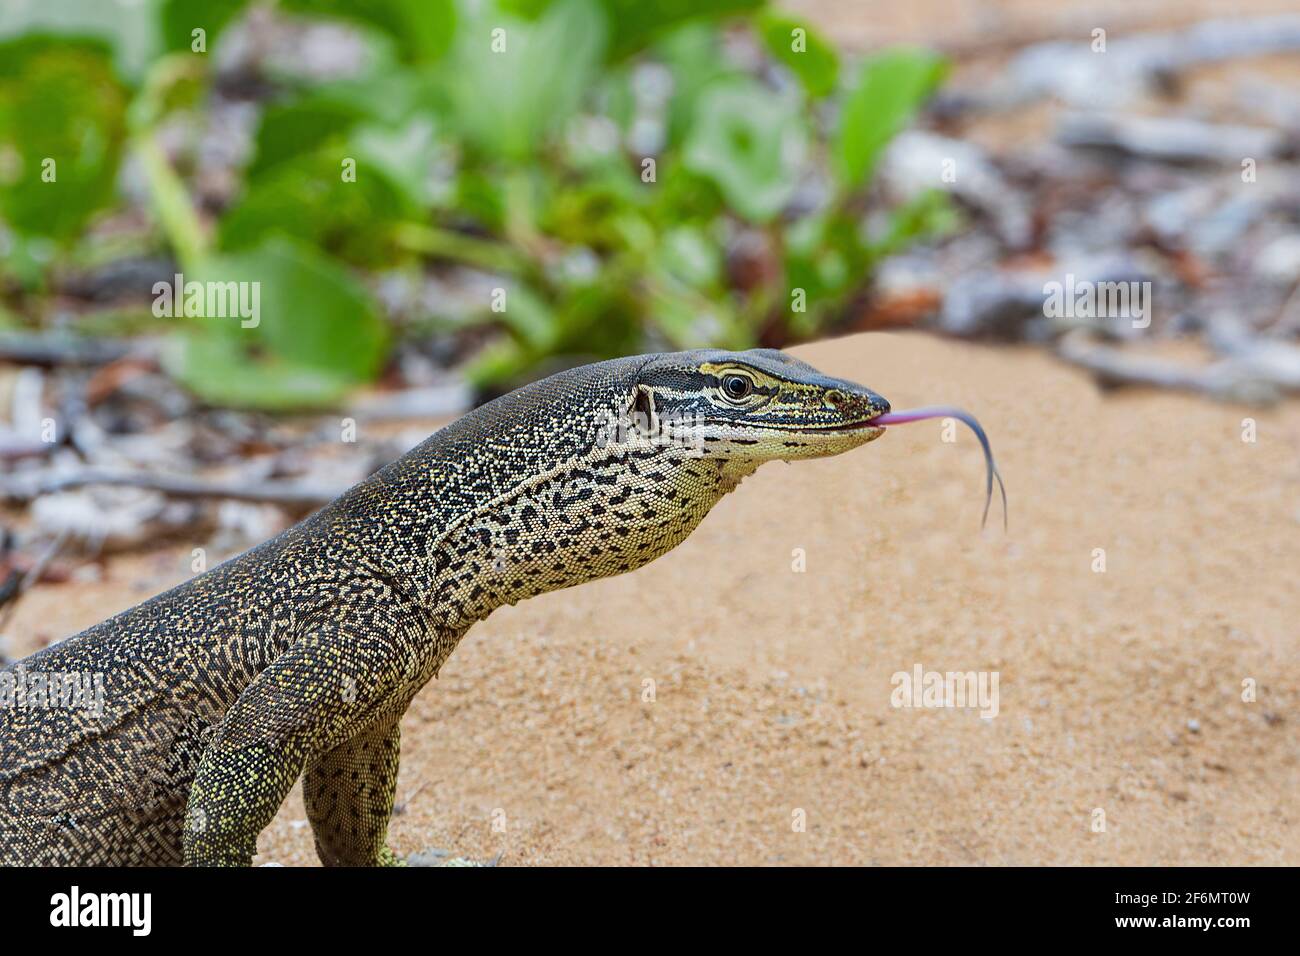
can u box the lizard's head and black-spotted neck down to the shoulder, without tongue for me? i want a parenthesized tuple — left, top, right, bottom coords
(395, 349, 889, 627)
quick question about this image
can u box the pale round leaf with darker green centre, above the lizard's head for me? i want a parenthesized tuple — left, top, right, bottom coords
(683, 79, 807, 222)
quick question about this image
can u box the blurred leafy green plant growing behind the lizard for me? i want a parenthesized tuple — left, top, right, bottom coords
(0, 0, 952, 408)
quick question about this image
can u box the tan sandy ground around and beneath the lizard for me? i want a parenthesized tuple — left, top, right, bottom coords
(10, 334, 1300, 865)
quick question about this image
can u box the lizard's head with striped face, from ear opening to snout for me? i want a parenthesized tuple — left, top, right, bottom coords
(629, 349, 889, 464)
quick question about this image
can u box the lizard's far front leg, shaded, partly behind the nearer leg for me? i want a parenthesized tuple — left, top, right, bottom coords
(303, 721, 402, 866)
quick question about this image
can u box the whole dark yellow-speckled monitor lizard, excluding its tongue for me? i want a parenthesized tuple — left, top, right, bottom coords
(0, 350, 888, 865)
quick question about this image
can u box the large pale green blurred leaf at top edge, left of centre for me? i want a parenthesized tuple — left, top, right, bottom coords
(445, 0, 605, 160)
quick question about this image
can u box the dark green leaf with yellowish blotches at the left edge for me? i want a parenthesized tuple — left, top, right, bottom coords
(0, 36, 127, 241)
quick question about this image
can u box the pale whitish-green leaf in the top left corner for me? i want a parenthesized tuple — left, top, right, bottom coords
(0, 0, 161, 81)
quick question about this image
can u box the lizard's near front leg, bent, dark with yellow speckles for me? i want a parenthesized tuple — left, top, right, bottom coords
(183, 593, 420, 866)
